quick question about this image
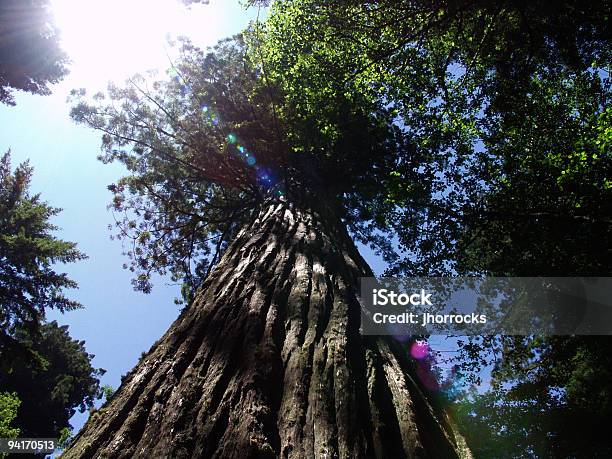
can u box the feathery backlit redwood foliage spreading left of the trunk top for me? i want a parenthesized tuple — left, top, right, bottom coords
(72, 39, 278, 299)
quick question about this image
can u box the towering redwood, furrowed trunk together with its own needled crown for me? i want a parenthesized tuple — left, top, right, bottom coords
(65, 32, 469, 457)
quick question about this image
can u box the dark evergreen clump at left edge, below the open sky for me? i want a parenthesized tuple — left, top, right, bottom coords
(0, 152, 104, 437)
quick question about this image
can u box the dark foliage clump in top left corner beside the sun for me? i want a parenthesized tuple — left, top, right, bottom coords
(0, 0, 68, 105)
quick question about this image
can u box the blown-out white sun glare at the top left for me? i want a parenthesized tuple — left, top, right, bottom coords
(51, 0, 230, 89)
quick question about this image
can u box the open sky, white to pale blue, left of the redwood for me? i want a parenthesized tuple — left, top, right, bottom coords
(0, 0, 464, 431)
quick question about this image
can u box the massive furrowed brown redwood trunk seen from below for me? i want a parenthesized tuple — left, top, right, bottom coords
(62, 196, 469, 458)
